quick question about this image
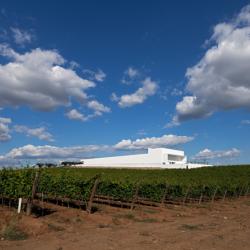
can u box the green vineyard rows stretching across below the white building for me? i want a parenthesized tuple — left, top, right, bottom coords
(0, 165, 250, 211)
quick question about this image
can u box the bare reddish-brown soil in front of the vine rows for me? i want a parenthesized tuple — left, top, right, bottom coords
(0, 197, 250, 250)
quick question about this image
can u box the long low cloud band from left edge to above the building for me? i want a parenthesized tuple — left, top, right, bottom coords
(0, 135, 194, 165)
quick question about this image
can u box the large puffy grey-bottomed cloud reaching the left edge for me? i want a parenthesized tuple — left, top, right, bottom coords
(0, 44, 95, 111)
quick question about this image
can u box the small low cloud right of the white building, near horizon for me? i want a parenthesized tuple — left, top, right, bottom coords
(194, 148, 240, 160)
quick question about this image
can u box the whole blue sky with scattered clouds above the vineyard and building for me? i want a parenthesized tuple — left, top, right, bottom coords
(0, 0, 250, 166)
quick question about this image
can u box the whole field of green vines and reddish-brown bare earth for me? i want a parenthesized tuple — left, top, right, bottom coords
(0, 165, 250, 250)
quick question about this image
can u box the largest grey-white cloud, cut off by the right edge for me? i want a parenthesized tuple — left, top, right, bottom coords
(174, 5, 250, 124)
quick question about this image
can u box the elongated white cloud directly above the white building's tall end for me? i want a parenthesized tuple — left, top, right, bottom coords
(114, 135, 194, 150)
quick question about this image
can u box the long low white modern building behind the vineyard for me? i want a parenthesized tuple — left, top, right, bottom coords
(78, 148, 208, 168)
